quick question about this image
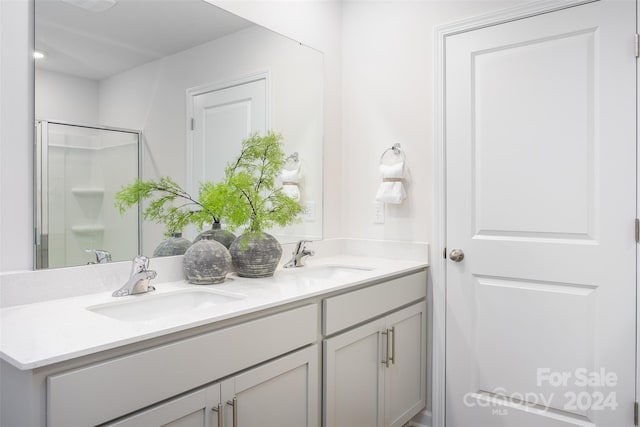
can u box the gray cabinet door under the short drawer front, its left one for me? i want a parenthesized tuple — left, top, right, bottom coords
(324, 320, 386, 427)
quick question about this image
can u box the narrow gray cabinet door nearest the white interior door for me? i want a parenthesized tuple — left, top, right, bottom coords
(384, 302, 427, 427)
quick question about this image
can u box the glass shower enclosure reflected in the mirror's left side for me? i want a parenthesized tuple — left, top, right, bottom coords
(34, 120, 141, 268)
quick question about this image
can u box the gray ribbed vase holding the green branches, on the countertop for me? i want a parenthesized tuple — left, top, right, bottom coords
(229, 233, 282, 278)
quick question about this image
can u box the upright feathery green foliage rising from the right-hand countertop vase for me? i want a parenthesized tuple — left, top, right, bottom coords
(225, 131, 304, 234)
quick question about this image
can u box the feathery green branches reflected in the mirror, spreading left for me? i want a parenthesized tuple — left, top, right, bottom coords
(115, 177, 228, 235)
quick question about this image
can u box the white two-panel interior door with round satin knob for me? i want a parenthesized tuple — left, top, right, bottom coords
(445, 0, 636, 427)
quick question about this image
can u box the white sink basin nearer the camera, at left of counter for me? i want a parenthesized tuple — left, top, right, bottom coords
(87, 289, 245, 322)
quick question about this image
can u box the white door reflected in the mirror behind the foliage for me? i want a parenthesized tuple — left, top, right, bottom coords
(187, 77, 269, 194)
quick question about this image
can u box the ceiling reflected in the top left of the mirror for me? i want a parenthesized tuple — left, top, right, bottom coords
(35, 0, 255, 80)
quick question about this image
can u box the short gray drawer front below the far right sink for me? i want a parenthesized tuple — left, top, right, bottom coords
(322, 270, 427, 335)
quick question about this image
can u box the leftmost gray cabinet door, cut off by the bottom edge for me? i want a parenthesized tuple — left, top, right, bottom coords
(104, 384, 221, 427)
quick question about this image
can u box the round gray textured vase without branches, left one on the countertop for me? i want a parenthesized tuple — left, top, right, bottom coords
(182, 236, 231, 285)
